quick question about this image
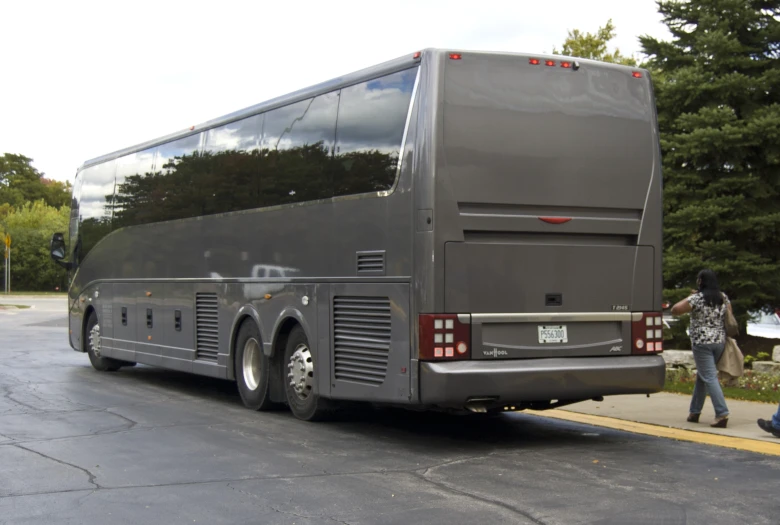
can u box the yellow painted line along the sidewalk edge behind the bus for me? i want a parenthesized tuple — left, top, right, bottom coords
(525, 409, 780, 456)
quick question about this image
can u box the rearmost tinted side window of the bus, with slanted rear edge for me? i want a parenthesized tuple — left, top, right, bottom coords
(333, 68, 417, 195)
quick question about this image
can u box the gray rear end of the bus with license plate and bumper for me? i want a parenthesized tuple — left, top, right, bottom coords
(416, 52, 664, 411)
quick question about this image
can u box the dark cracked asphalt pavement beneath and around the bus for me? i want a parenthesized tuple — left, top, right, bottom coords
(0, 298, 780, 525)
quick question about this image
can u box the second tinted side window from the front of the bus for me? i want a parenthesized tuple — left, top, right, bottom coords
(114, 150, 154, 228)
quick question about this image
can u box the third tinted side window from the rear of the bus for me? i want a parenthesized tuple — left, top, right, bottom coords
(200, 115, 263, 213)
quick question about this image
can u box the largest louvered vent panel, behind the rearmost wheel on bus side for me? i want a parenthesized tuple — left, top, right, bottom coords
(333, 297, 391, 386)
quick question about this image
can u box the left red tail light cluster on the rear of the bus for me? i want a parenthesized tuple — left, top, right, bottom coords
(418, 314, 471, 361)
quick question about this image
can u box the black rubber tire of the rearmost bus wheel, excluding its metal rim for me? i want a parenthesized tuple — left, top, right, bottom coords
(282, 325, 336, 421)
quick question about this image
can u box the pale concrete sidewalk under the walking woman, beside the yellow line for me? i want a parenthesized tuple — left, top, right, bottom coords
(560, 392, 780, 444)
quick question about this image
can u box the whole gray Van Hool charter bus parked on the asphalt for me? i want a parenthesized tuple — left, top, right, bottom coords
(51, 49, 664, 420)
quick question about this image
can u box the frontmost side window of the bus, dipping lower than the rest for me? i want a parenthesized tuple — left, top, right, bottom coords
(74, 160, 116, 263)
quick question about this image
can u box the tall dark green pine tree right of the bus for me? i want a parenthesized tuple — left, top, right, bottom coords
(640, 0, 780, 321)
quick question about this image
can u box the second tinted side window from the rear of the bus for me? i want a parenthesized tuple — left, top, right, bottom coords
(260, 93, 338, 206)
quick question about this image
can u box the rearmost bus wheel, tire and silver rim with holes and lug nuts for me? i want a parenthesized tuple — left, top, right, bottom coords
(282, 326, 333, 421)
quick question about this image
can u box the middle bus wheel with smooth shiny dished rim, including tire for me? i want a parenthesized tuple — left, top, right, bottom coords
(233, 321, 273, 410)
